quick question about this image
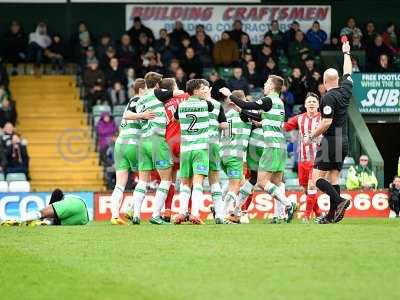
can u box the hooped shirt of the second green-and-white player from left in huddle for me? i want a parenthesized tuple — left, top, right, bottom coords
(136, 90, 167, 138)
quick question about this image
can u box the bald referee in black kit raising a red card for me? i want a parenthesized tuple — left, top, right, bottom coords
(304, 40, 353, 224)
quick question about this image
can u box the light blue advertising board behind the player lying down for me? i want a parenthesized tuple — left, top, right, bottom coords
(0, 192, 93, 220)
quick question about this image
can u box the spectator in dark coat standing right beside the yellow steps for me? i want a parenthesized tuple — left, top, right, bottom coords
(83, 60, 106, 111)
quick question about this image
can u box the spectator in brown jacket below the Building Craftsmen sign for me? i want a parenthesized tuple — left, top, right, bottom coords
(213, 31, 239, 67)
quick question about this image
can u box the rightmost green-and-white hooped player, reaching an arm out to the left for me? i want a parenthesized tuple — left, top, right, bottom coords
(220, 75, 296, 222)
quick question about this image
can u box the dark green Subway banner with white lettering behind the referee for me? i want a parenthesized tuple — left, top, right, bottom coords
(351, 73, 400, 114)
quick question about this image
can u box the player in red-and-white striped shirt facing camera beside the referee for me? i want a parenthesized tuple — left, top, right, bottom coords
(284, 93, 321, 221)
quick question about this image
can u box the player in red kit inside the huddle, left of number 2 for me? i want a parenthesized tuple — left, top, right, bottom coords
(160, 78, 189, 221)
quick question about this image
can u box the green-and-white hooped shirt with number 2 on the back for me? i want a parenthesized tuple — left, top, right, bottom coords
(175, 96, 213, 153)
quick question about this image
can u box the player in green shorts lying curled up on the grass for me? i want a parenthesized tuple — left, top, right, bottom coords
(1, 189, 89, 226)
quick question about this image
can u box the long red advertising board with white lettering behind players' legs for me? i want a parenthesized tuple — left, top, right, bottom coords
(94, 190, 390, 220)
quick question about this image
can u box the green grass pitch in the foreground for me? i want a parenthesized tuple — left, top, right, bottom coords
(0, 219, 400, 300)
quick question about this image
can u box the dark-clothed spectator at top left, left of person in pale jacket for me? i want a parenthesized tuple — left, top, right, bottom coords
(4, 21, 28, 75)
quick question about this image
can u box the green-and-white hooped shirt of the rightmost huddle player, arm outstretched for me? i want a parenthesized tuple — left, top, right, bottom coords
(261, 93, 286, 149)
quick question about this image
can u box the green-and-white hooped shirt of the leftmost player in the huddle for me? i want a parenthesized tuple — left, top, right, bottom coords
(115, 97, 141, 145)
